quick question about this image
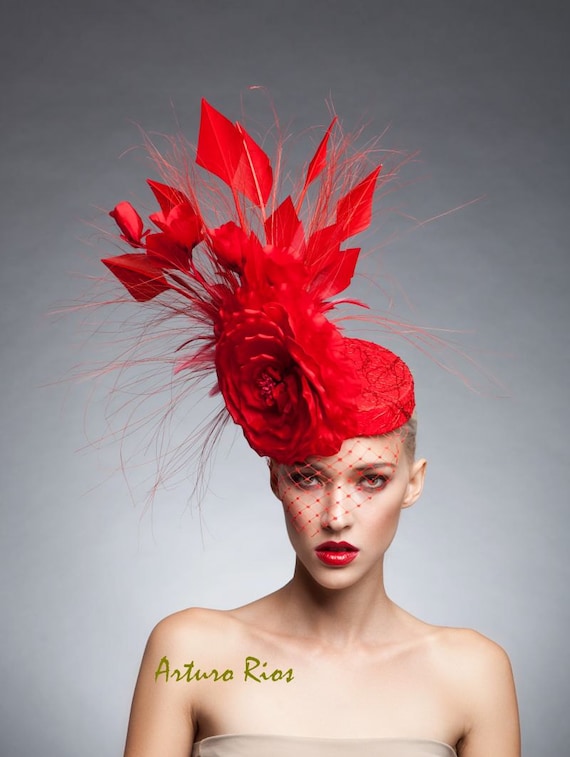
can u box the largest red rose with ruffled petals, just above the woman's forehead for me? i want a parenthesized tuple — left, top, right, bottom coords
(216, 303, 355, 464)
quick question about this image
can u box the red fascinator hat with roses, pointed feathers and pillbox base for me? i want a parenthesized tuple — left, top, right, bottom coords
(103, 101, 414, 464)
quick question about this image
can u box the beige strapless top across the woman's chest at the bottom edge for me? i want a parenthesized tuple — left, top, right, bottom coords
(192, 734, 457, 757)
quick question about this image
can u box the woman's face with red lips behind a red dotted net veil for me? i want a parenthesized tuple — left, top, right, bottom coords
(271, 434, 426, 588)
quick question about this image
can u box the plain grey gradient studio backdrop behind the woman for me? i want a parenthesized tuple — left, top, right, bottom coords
(0, 0, 570, 757)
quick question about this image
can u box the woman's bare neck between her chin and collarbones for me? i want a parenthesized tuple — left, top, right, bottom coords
(280, 561, 397, 647)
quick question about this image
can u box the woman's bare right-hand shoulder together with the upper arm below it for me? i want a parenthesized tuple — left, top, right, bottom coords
(428, 628, 520, 757)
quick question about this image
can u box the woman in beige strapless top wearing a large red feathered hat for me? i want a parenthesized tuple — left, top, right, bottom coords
(100, 103, 520, 757)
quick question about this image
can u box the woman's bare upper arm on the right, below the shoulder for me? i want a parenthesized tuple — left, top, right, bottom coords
(452, 636, 520, 757)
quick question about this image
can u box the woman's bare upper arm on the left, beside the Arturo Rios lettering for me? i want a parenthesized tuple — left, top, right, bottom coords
(125, 616, 195, 757)
